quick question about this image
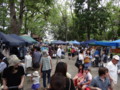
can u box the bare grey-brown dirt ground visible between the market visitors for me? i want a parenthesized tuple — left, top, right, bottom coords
(24, 56, 120, 90)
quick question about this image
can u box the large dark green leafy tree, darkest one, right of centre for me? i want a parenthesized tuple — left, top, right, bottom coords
(75, 0, 108, 40)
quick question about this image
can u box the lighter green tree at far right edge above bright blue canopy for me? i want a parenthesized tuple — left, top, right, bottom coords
(106, 1, 120, 40)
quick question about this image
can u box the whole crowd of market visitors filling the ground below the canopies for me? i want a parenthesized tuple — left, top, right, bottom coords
(0, 45, 120, 90)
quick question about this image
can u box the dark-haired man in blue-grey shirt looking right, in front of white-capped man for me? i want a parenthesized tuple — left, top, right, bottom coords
(90, 67, 113, 90)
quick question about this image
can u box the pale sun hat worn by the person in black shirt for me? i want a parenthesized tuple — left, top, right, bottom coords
(8, 55, 20, 66)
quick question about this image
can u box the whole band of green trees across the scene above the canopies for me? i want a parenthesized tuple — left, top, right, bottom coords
(0, 0, 120, 41)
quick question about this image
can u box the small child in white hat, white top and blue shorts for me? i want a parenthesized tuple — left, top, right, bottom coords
(31, 71, 40, 90)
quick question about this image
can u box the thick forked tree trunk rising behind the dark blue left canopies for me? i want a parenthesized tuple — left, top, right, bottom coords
(9, 0, 24, 34)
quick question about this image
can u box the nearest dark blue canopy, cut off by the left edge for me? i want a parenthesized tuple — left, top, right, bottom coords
(0, 32, 24, 46)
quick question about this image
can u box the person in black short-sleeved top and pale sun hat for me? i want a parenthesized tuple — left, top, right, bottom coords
(2, 55, 25, 90)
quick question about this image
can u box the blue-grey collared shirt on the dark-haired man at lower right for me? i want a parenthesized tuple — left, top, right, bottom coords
(90, 76, 111, 90)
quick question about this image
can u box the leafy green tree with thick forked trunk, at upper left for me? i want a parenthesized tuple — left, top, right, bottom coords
(0, 0, 53, 34)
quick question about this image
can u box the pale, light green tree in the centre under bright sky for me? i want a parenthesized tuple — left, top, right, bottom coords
(49, 1, 71, 41)
